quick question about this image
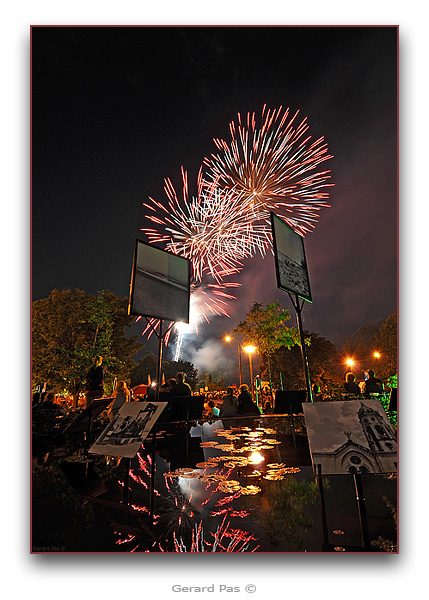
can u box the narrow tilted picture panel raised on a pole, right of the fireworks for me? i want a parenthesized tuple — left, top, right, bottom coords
(270, 212, 312, 302)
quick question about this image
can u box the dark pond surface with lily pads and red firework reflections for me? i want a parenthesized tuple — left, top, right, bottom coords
(32, 417, 396, 553)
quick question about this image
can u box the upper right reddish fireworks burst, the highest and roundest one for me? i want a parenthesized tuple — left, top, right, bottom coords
(204, 106, 333, 235)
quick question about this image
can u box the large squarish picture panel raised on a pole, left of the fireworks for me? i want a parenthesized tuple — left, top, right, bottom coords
(128, 240, 191, 323)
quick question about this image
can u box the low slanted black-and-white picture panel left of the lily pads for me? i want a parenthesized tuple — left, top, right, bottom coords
(89, 402, 167, 458)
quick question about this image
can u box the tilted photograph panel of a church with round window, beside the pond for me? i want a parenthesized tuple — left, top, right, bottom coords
(304, 399, 397, 474)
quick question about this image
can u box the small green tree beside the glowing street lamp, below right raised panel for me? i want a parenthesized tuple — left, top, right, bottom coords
(233, 300, 300, 392)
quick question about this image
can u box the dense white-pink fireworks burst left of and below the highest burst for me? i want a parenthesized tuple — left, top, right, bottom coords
(142, 167, 270, 283)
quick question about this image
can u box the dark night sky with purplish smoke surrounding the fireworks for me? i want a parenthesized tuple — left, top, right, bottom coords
(32, 27, 398, 376)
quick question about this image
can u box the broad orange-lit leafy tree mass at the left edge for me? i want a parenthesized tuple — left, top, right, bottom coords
(32, 289, 142, 403)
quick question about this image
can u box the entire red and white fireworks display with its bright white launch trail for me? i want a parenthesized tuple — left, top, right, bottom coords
(142, 106, 333, 350)
